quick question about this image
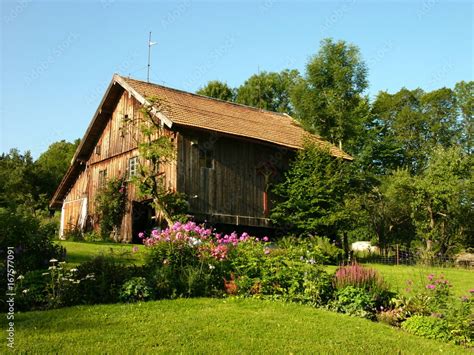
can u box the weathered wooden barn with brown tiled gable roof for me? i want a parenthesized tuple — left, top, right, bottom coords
(50, 74, 351, 242)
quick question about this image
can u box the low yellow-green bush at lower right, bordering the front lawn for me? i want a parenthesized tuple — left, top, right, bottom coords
(402, 316, 452, 341)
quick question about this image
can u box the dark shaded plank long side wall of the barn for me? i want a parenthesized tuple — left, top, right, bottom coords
(177, 129, 292, 227)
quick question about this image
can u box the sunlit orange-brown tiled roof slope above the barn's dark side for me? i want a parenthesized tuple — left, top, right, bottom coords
(120, 75, 352, 160)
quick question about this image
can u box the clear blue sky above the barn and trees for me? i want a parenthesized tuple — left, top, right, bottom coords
(0, 0, 474, 158)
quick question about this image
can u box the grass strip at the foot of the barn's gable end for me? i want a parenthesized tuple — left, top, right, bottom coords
(58, 240, 145, 267)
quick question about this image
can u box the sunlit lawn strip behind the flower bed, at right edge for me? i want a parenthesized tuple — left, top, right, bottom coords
(325, 264, 474, 296)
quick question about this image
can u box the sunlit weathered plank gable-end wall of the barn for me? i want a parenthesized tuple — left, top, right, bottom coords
(62, 92, 176, 241)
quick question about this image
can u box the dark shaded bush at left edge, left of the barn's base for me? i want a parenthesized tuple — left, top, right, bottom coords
(0, 206, 65, 274)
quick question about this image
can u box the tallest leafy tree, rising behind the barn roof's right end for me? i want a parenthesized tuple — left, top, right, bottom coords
(292, 39, 368, 151)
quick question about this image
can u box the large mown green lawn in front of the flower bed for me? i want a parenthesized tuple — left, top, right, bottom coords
(15, 299, 471, 354)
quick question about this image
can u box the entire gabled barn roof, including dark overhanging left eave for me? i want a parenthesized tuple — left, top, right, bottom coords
(50, 74, 352, 207)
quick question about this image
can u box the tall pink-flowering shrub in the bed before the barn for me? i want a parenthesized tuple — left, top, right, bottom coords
(139, 222, 268, 298)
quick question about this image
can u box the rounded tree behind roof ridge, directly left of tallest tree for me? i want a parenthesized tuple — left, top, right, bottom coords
(236, 69, 301, 115)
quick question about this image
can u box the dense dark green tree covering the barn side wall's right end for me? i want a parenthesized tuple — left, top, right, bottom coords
(271, 143, 350, 240)
